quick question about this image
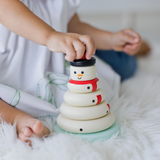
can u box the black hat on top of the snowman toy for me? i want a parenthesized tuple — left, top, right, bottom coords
(70, 57, 96, 67)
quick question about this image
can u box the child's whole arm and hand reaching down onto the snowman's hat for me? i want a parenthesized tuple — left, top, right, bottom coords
(0, 0, 95, 61)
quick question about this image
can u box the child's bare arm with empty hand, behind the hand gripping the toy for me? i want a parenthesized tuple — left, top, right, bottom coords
(68, 14, 141, 55)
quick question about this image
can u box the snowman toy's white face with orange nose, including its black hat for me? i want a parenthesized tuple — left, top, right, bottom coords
(70, 57, 96, 81)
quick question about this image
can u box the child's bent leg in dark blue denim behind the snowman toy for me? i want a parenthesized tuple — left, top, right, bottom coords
(96, 50, 137, 81)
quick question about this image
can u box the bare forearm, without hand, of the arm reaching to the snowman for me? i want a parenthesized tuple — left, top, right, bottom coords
(0, 0, 54, 45)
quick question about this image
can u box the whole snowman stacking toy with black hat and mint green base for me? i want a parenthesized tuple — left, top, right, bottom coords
(54, 55, 118, 141)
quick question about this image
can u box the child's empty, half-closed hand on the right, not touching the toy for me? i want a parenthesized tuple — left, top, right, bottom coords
(110, 29, 141, 55)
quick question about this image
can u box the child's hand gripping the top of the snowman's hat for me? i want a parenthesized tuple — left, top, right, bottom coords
(47, 31, 96, 61)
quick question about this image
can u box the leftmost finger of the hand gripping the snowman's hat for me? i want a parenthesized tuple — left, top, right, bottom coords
(65, 45, 76, 61)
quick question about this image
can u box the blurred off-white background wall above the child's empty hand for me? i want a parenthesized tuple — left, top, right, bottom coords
(78, 0, 160, 41)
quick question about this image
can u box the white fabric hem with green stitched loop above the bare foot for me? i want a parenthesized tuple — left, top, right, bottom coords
(0, 84, 59, 117)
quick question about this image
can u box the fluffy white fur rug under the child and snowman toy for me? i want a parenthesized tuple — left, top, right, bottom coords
(0, 42, 160, 160)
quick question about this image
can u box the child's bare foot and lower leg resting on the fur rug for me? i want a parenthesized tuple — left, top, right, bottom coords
(0, 99, 50, 142)
